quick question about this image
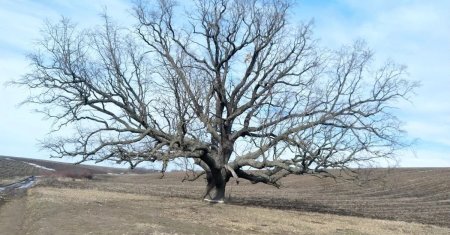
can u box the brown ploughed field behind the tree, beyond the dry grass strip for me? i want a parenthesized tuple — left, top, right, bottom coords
(34, 168, 450, 227)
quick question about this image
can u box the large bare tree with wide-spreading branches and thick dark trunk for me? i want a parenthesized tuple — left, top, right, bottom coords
(16, 0, 415, 201)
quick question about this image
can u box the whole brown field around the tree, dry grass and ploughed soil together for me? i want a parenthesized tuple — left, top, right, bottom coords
(0, 158, 450, 234)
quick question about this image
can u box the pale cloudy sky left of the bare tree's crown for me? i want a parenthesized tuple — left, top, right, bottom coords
(0, 0, 130, 160)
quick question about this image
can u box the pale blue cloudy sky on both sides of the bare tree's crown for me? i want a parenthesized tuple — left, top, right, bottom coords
(0, 0, 450, 167)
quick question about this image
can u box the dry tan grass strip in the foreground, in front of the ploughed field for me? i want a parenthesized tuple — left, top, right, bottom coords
(0, 187, 450, 234)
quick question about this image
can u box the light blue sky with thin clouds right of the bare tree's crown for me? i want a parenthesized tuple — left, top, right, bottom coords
(298, 0, 450, 166)
